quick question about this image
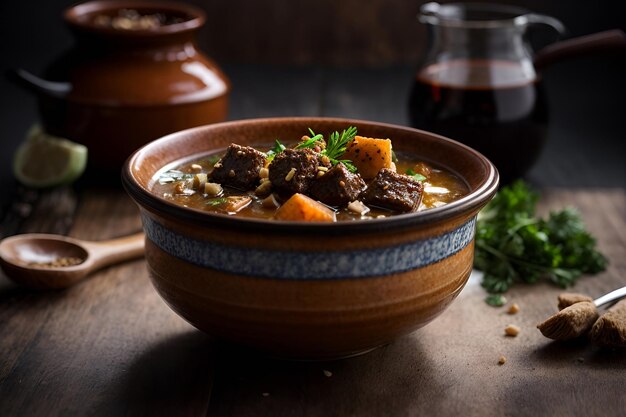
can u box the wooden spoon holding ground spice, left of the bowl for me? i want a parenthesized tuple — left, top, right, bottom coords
(0, 233, 144, 289)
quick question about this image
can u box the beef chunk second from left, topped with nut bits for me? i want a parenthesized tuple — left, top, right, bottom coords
(269, 149, 320, 195)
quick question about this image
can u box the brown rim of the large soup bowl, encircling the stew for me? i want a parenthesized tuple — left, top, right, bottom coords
(121, 117, 499, 235)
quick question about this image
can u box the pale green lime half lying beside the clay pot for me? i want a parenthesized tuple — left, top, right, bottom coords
(13, 127, 87, 188)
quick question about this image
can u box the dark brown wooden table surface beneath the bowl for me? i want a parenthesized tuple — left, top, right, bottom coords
(0, 67, 626, 417)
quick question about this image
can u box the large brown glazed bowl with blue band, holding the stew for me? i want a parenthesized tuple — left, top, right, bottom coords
(122, 118, 498, 359)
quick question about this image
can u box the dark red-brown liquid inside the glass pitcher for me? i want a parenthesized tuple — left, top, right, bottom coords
(409, 60, 547, 183)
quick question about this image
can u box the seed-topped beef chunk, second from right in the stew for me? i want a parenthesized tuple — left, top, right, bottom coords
(309, 163, 365, 207)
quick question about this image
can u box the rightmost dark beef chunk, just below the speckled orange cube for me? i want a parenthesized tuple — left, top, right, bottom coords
(361, 168, 424, 211)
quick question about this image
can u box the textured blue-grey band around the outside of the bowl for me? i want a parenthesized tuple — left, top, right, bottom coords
(142, 214, 476, 279)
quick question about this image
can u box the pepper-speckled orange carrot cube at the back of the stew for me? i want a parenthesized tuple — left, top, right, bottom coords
(341, 136, 392, 179)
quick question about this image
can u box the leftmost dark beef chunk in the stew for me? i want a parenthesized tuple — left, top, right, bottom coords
(211, 143, 265, 191)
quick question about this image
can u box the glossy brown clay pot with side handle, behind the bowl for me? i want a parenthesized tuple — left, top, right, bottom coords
(9, 0, 230, 173)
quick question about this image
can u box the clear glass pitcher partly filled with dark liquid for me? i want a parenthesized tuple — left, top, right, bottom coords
(409, 3, 564, 182)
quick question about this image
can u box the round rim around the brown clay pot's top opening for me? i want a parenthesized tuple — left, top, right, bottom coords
(63, 0, 206, 38)
